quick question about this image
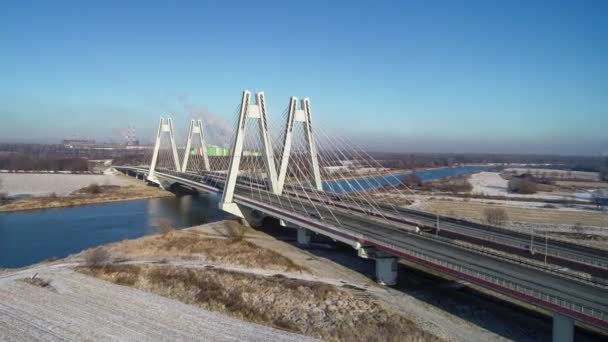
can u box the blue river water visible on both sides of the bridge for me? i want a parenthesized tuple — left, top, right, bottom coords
(0, 166, 486, 268)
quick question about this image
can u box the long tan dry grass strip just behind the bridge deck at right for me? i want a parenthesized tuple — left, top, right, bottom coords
(425, 199, 608, 227)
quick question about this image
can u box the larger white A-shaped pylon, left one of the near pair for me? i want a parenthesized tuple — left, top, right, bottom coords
(220, 90, 277, 217)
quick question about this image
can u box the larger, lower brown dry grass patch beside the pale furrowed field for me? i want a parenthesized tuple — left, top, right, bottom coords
(79, 265, 438, 341)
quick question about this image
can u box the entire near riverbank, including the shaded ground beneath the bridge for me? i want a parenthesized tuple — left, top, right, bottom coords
(0, 221, 588, 341)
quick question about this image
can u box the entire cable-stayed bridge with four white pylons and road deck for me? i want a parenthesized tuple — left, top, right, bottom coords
(115, 91, 608, 341)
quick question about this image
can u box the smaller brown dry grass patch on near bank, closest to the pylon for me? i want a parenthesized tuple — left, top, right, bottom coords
(111, 227, 307, 272)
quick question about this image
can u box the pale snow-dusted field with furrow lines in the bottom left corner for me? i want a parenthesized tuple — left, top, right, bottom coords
(0, 266, 312, 341)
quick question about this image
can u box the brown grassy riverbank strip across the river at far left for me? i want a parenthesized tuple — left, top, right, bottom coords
(0, 183, 174, 212)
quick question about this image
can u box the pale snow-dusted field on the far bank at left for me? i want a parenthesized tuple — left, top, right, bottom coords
(0, 173, 141, 196)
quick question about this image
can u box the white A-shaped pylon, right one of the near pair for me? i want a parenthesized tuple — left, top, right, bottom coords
(275, 97, 323, 195)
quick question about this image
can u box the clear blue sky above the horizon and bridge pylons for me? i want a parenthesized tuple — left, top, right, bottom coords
(0, 1, 608, 154)
